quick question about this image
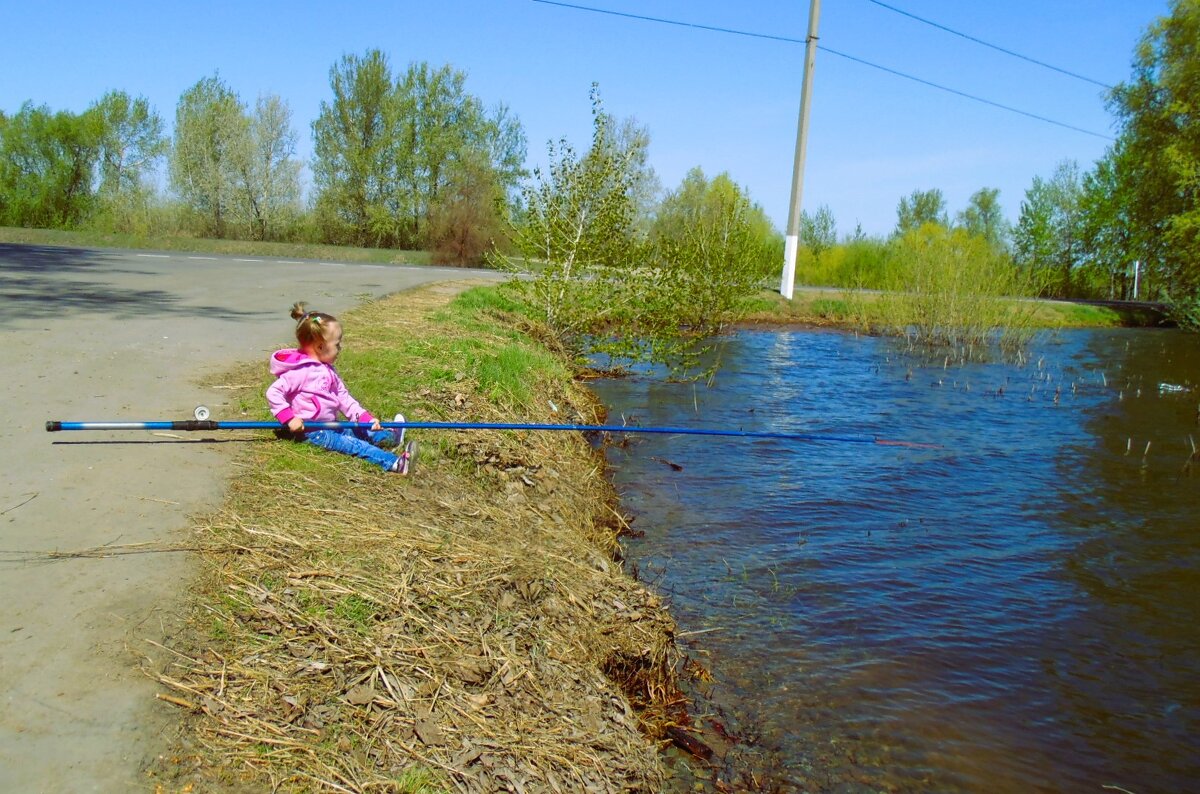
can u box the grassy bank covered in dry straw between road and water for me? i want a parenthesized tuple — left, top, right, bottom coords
(148, 285, 677, 792)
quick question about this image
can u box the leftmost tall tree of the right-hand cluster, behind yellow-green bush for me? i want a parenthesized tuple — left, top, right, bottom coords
(1013, 160, 1084, 297)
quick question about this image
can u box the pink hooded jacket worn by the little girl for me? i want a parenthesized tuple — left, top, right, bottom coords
(266, 349, 374, 425)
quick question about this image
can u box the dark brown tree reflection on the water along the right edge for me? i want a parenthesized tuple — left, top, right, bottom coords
(1048, 332, 1200, 788)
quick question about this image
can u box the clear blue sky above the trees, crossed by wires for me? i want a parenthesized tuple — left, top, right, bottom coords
(0, 0, 1169, 235)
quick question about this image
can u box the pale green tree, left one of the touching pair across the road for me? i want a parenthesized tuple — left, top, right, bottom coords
(170, 76, 250, 237)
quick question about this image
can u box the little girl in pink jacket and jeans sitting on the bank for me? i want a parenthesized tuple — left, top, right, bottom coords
(266, 303, 416, 474)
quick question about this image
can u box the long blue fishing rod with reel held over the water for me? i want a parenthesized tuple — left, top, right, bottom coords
(46, 405, 941, 450)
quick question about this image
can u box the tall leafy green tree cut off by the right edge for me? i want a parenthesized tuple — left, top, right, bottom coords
(1110, 0, 1200, 305)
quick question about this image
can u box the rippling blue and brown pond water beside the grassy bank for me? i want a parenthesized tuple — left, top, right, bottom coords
(595, 330, 1200, 794)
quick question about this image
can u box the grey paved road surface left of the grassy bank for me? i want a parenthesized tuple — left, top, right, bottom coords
(0, 245, 499, 793)
